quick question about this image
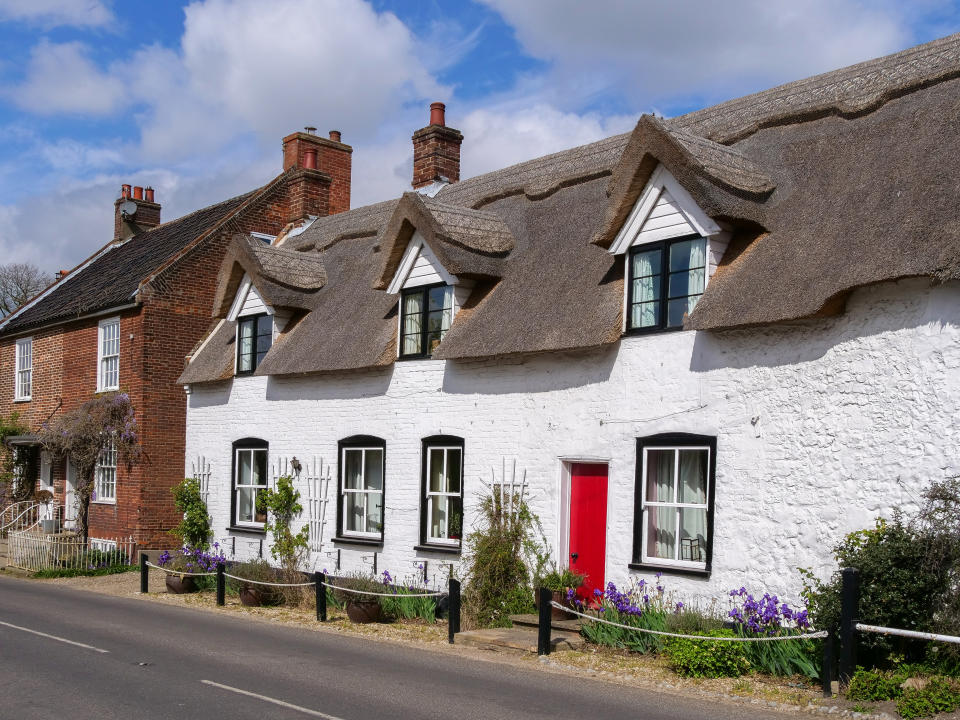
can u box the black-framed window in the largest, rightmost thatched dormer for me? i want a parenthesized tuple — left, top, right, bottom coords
(627, 237, 707, 331)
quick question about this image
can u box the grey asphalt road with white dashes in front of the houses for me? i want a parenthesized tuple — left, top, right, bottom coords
(0, 577, 785, 720)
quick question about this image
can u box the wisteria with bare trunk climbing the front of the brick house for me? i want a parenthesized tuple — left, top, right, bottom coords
(40, 392, 141, 539)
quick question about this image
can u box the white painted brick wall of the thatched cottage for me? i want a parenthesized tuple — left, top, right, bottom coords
(187, 280, 960, 599)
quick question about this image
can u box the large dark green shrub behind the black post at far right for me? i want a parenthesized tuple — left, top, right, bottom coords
(804, 513, 955, 665)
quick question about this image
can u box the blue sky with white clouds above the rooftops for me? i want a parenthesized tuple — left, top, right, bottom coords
(0, 0, 960, 272)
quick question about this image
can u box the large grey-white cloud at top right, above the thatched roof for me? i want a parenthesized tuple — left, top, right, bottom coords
(481, 0, 910, 107)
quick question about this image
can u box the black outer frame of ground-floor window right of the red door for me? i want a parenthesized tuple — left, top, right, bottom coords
(629, 432, 717, 577)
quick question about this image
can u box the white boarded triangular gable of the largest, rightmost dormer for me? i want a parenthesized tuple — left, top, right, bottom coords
(609, 165, 723, 255)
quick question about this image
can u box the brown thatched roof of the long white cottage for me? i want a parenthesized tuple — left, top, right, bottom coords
(182, 35, 960, 382)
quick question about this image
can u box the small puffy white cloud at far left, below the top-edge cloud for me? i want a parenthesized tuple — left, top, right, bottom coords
(6, 40, 125, 115)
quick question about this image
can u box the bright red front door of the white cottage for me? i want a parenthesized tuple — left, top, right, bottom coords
(569, 463, 607, 599)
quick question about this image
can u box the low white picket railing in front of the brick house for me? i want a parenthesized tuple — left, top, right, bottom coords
(7, 530, 136, 572)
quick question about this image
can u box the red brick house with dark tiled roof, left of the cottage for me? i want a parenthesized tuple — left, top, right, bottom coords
(0, 128, 352, 547)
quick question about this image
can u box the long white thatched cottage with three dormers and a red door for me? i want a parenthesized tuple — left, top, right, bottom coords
(180, 35, 960, 596)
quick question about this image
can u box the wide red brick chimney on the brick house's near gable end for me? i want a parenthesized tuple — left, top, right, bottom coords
(283, 127, 353, 217)
